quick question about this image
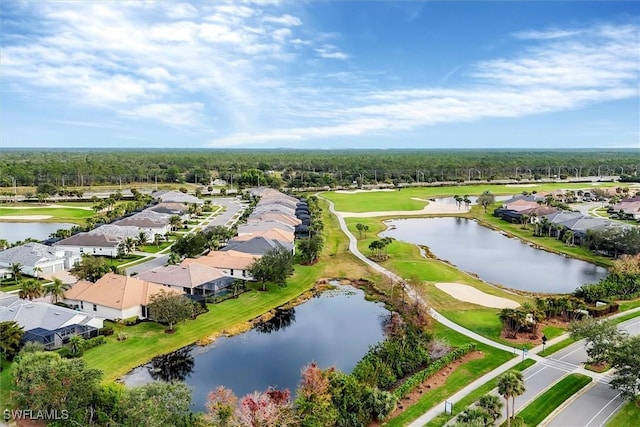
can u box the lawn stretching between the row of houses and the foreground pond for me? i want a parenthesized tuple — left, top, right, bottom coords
(84, 199, 378, 381)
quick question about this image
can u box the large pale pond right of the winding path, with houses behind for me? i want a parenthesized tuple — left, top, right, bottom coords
(381, 218, 607, 293)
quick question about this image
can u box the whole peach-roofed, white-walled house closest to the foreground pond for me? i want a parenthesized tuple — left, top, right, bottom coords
(64, 273, 182, 320)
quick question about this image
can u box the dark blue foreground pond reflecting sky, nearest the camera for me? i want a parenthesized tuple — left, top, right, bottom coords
(123, 286, 388, 411)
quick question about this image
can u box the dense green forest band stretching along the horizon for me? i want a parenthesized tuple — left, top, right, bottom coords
(0, 150, 639, 190)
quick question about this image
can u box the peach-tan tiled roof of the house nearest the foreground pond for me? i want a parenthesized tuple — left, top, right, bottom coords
(64, 273, 176, 310)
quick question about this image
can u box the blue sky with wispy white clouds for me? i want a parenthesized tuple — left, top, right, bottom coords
(0, 0, 640, 149)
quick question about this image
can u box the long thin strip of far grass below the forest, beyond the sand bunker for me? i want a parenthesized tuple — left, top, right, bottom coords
(322, 183, 621, 212)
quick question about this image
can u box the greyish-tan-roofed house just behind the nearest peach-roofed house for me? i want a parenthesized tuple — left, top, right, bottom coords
(136, 262, 235, 296)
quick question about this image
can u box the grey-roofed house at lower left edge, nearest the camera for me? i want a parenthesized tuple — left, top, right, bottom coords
(0, 299, 104, 350)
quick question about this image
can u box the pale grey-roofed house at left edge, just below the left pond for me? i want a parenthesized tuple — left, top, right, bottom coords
(0, 242, 78, 277)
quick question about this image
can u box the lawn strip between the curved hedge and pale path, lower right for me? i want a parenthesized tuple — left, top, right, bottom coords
(384, 323, 514, 427)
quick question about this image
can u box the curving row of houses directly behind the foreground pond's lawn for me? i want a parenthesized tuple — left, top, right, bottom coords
(65, 190, 308, 319)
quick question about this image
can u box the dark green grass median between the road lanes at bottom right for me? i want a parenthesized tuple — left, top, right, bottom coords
(518, 374, 592, 427)
